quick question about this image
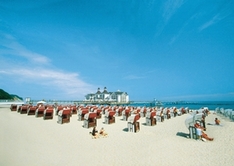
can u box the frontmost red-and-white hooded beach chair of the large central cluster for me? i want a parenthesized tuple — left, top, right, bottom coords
(128, 113, 141, 133)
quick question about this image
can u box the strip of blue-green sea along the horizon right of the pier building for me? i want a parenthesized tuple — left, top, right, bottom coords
(130, 101, 234, 110)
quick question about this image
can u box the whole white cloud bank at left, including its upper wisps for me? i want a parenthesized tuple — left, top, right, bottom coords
(0, 35, 96, 98)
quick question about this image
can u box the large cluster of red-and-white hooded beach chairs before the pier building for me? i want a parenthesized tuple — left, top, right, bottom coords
(11, 105, 189, 132)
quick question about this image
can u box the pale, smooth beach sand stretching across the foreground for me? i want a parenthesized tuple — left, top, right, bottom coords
(0, 108, 234, 166)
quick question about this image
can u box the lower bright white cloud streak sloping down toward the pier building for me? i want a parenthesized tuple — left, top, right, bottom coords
(0, 67, 94, 98)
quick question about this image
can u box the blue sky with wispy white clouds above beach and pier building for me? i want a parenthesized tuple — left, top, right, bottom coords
(0, 0, 234, 101)
